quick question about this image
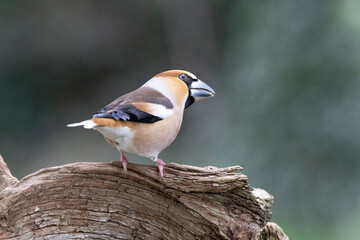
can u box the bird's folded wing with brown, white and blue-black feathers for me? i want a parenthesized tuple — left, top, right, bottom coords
(93, 87, 174, 123)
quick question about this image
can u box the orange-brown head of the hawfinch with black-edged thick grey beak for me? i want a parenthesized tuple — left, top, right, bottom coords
(144, 70, 215, 108)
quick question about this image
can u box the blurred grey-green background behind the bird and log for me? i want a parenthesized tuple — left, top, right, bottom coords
(0, 0, 360, 239)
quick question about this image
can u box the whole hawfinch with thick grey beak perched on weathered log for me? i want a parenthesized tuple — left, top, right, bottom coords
(67, 70, 215, 176)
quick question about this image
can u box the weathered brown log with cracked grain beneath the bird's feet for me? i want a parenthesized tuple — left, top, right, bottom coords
(0, 156, 288, 240)
